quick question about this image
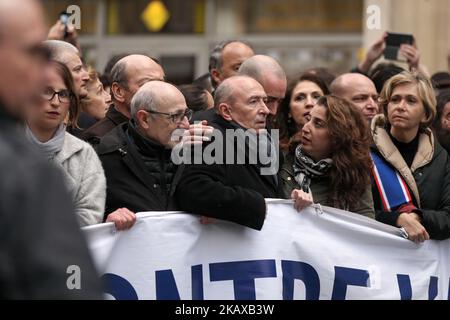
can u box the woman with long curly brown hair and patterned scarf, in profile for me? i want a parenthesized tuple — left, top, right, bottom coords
(281, 95, 375, 218)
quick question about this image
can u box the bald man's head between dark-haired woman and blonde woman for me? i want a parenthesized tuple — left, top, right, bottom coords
(330, 73, 379, 121)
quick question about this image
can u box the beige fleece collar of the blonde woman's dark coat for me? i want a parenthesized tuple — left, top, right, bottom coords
(371, 114, 435, 207)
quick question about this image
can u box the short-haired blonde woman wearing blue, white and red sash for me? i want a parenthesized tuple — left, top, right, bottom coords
(371, 71, 450, 242)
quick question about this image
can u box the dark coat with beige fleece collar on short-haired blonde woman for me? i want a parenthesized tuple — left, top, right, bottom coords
(372, 116, 450, 239)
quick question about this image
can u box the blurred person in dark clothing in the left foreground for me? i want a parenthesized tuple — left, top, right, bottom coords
(0, 0, 102, 299)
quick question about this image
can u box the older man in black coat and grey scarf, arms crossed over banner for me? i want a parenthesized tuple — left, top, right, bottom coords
(175, 76, 284, 230)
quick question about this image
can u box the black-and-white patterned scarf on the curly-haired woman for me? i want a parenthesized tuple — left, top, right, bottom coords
(294, 145, 333, 192)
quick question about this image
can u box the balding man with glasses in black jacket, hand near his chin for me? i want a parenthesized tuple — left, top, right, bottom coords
(97, 80, 212, 216)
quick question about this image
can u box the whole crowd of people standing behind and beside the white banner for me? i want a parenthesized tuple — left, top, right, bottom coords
(0, 0, 450, 298)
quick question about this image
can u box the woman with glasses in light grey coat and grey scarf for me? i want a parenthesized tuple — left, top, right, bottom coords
(25, 62, 106, 226)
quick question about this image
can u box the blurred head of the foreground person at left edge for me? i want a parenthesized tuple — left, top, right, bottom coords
(0, 0, 46, 115)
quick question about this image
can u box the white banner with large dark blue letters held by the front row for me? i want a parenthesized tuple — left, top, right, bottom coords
(84, 199, 450, 300)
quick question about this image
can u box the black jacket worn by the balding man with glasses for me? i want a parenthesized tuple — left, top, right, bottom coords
(95, 123, 182, 218)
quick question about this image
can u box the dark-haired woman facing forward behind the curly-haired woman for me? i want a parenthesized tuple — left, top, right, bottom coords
(274, 73, 330, 153)
